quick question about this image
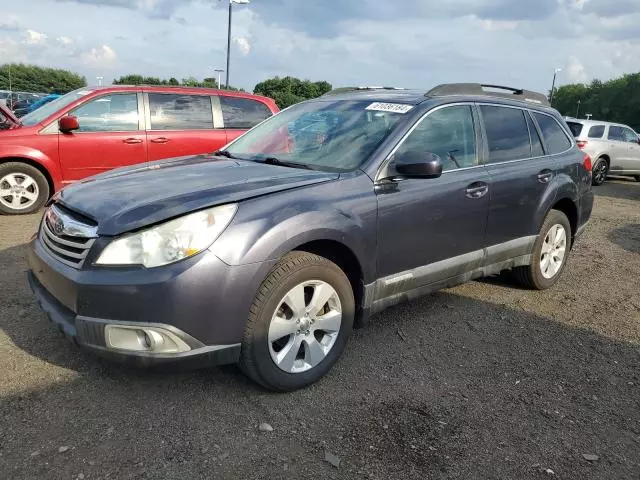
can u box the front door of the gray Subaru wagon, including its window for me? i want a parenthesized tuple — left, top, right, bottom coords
(376, 105, 491, 288)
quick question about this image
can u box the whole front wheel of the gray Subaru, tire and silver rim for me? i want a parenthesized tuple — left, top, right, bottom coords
(240, 252, 355, 392)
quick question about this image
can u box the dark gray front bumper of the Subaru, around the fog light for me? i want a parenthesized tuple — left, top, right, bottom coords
(27, 234, 270, 366)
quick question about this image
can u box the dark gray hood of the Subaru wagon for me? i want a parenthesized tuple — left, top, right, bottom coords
(54, 155, 339, 235)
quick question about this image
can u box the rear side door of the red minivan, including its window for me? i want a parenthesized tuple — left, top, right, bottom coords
(145, 92, 227, 161)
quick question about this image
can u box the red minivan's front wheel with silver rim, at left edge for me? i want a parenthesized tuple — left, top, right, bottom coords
(0, 162, 49, 215)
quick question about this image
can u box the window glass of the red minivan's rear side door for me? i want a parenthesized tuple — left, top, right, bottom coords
(149, 93, 213, 130)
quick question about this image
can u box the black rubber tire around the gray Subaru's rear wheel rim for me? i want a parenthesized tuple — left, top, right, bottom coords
(513, 210, 572, 290)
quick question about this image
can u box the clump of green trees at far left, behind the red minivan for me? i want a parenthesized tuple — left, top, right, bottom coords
(0, 63, 87, 94)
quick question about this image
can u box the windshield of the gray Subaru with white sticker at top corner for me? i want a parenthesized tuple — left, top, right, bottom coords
(226, 100, 412, 171)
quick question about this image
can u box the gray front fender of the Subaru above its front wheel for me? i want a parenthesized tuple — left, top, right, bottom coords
(211, 175, 377, 282)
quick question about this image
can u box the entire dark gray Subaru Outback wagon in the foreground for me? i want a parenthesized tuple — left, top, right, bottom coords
(28, 84, 593, 391)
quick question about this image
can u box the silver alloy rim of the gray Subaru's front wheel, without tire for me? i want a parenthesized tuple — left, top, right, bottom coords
(268, 280, 342, 373)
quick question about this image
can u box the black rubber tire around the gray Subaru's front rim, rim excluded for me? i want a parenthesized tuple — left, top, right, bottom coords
(240, 251, 355, 392)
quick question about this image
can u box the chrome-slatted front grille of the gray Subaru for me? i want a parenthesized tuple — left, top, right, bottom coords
(40, 206, 96, 268)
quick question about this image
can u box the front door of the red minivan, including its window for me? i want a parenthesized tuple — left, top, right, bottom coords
(58, 92, 147, 183)
